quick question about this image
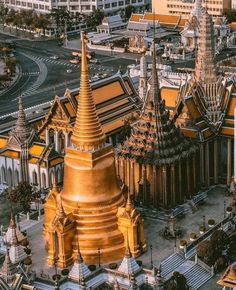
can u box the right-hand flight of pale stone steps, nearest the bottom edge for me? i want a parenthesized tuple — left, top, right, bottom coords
(184, 264, 212, 290)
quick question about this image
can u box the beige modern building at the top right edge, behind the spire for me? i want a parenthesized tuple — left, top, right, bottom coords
(152, 0, 232, 19)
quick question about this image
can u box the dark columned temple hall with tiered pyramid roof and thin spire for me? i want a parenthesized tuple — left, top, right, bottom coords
(116, 40, 200, 208)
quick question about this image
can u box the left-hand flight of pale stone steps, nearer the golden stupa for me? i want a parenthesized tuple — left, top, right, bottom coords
(161, 253, 185, 278)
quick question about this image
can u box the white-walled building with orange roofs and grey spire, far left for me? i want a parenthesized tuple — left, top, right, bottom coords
(0, 98, 63, 189)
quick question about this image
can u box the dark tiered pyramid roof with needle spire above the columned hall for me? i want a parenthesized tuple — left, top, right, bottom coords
(116, 44, 196, 164)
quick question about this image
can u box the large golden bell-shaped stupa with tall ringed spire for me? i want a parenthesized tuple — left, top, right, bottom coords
(44, 33, 145, 267)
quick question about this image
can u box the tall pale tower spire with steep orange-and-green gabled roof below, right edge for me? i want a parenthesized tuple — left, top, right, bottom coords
(176, 9, 236, 141)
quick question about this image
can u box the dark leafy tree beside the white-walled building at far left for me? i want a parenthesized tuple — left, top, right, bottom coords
(6, 181, 38, 212)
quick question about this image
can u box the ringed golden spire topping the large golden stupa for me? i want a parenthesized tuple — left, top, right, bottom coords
(71, 32, 106, 151)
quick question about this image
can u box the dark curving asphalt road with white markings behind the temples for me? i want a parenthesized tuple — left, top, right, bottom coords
(0, 34, 134, 115)
